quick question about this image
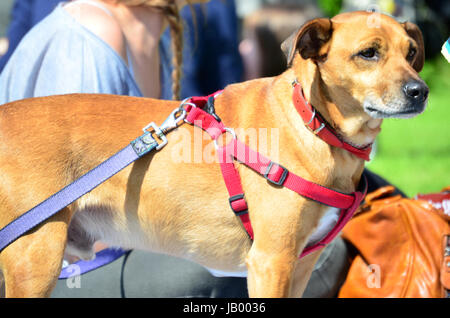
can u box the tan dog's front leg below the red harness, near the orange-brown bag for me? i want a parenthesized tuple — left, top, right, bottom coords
(246, 192, 320, 298)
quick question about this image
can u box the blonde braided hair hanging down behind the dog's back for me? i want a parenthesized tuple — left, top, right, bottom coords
(115, 0, 186, 100)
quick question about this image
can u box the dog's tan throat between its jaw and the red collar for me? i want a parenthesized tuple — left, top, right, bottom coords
(294, 58, 382, 148)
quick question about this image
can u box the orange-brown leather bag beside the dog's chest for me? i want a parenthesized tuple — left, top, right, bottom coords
(338, 186, 450, 298)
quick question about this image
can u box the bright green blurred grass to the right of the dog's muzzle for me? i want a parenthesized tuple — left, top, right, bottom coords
(367, 56, 450, 196)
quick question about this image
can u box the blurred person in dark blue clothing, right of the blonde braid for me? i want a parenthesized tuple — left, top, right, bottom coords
(178, 0, 243, 99)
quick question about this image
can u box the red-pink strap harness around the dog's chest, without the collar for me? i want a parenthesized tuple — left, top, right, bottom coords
(181, 93, 367, 258)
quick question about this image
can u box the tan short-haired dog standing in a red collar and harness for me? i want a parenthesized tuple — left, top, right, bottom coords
(0, 12, 428, 297)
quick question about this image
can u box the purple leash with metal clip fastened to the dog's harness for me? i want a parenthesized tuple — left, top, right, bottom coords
(0, 102, 186, 275)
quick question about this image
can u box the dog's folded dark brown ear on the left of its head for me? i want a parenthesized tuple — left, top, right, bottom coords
(281, 18, 332, 66)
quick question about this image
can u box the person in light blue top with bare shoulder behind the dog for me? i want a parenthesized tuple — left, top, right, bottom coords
(0, 0, 176, 103)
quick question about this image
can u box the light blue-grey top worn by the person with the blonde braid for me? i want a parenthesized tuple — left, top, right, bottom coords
(0, 5, 172, 105)
